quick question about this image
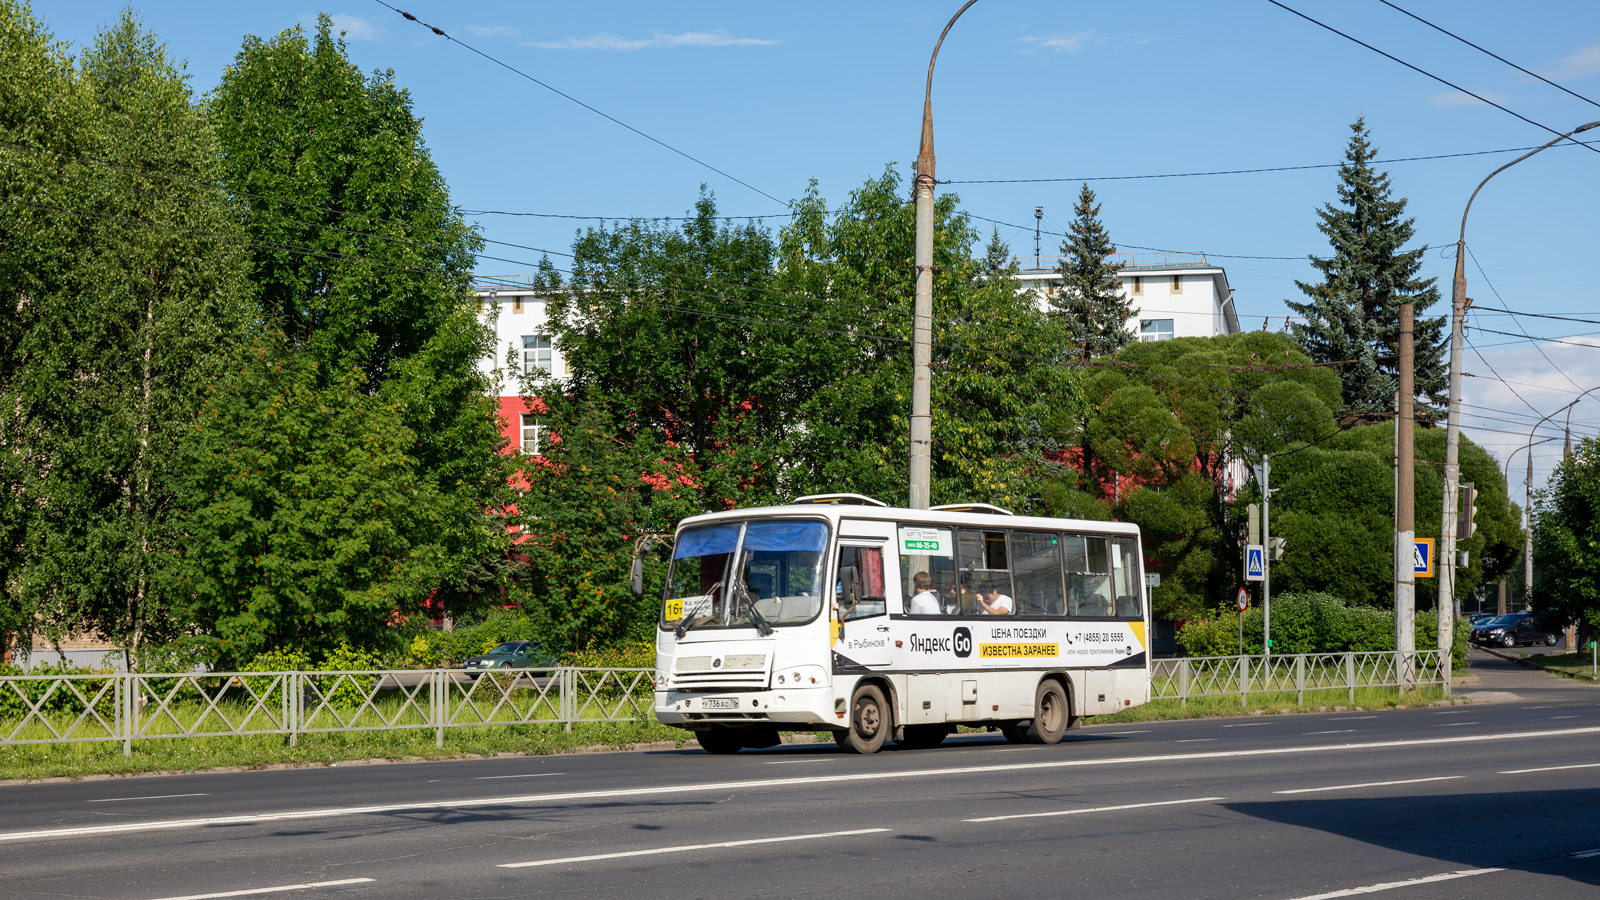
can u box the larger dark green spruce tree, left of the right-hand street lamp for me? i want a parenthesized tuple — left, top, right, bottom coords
(1285, 119, 1446, 418)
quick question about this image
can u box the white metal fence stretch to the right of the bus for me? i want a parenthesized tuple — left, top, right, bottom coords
(1150, 650, 1450, 705)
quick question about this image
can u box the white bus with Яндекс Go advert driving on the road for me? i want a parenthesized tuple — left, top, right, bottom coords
(654, 495, 1150, 753)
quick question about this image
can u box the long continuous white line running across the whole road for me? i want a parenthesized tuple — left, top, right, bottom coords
(0, 725, 1600, 842)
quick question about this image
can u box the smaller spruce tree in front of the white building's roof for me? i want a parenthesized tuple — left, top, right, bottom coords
(1050, 183, 1133, 359)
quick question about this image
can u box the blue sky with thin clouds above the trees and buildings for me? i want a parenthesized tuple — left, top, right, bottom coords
(35, 0, 1600, 496)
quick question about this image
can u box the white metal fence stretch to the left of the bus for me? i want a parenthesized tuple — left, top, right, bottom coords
(0, 666, 654, 754)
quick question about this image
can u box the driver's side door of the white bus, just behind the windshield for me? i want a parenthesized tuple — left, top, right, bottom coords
(832, 522, 893, 671)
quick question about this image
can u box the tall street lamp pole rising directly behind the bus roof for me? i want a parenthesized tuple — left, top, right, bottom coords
(909, 0, 978, 509)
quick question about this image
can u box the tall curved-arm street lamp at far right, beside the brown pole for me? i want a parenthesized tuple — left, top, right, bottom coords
(1438, 122, 1600, 666)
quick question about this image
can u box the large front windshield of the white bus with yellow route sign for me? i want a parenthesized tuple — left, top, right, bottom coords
(661, 520, 827, 631)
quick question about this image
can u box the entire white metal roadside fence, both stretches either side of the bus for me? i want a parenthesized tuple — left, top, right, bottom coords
(0, 650, 1450, 753)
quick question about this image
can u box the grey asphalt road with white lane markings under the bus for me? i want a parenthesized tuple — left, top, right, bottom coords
(0, 650, 1600, 900)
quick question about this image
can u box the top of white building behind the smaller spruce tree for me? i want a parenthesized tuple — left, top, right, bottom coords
(1018, 253, 1240, 341)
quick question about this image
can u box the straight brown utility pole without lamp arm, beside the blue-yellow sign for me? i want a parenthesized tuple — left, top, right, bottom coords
(1395, 303, 1420, 689)
